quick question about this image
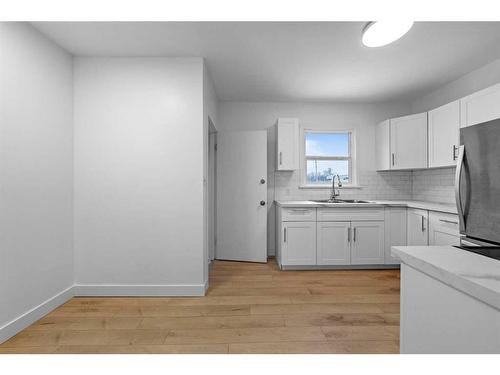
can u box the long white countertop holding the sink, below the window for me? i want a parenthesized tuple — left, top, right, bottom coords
(276, 200, 457, 214)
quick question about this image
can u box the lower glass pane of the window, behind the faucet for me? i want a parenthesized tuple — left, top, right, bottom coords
(306, 160, 349, 184)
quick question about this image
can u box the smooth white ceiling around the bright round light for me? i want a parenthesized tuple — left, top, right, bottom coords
(33, 22, 500, 102)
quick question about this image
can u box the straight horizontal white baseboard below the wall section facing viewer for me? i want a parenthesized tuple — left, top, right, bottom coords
(74, 284, 207, 297)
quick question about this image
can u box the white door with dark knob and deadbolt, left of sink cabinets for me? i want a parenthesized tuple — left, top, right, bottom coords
(215, 130, 267, 263)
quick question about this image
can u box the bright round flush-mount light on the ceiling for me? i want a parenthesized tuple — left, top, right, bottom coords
(362, 21, 413, 47)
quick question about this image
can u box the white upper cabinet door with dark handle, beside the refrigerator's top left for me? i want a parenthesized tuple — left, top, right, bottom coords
(428, 100, 460, 168)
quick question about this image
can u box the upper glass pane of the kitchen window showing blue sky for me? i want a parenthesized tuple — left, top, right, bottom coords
(305, 133, 349, 156)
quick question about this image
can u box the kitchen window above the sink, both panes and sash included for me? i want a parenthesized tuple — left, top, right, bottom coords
(302, 130, 355, 187)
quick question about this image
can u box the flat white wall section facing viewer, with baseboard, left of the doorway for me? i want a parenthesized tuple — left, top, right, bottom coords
(74, 57, 205, 295)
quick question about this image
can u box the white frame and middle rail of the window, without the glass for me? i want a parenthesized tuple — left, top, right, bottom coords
(299, 127, 359, 189)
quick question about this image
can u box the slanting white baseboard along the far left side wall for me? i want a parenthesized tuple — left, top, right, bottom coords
(0, 286, 73, 344)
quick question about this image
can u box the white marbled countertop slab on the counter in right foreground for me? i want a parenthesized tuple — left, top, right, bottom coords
(391, 246, 500, 310)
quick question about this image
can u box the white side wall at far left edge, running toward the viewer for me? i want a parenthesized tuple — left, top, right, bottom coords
(0, 23, 73, 342)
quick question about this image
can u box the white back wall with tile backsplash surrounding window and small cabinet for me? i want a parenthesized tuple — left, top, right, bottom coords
(218, 102, 411, 254)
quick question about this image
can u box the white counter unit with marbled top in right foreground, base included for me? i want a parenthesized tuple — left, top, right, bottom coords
(392, 246, 500, 353)
